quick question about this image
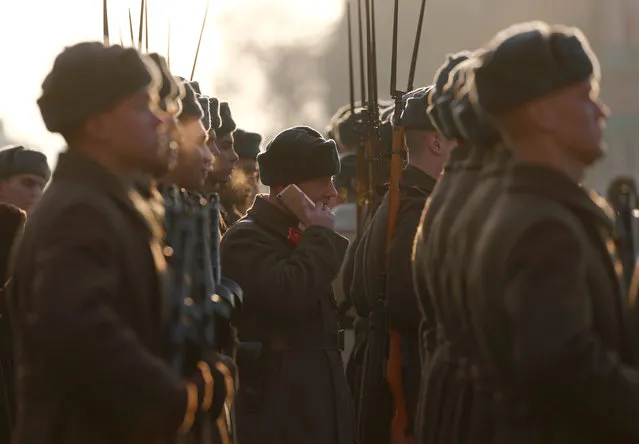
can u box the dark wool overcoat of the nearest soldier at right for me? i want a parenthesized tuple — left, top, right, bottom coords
(470, 165, 639, 443)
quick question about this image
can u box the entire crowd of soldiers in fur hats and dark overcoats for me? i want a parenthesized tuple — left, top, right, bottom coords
(0, 15, 639, 444)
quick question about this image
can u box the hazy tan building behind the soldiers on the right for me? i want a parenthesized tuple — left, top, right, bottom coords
(325, 0, 639, 193)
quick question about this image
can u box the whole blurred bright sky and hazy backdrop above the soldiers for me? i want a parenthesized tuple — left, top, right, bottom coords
(0, 0, 639, 193)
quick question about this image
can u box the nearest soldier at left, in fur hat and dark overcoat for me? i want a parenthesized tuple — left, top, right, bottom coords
(11, 43, 232, 444)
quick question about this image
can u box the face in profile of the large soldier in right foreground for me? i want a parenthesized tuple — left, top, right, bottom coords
(548, 80, 609, 166)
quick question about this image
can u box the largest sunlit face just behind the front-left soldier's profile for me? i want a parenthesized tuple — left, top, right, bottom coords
(173, 119, 213, 190)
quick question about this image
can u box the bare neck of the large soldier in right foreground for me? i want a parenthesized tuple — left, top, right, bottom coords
(509, 134, 586, 183)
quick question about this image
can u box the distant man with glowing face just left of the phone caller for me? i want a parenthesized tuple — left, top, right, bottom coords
(220, 129, 262, 225)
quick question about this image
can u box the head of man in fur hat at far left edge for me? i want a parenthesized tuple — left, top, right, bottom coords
(0, 145, 51, 212)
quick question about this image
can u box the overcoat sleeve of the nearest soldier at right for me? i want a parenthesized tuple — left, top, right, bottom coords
(504, 221, 639, 439)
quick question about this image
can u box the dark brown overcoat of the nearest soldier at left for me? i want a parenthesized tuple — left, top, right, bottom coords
(12, 153, 195, 444)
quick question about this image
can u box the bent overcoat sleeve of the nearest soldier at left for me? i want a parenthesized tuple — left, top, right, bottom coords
(29, 204, 187, 430)
